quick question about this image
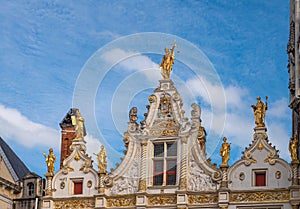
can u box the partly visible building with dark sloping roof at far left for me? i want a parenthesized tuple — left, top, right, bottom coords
(0, 138, 43, 209)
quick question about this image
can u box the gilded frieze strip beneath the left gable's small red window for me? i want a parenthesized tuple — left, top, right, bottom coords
(54, 198, 95, 209)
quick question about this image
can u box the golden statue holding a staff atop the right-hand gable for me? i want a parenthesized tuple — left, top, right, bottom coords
(251, 96, 268, 127)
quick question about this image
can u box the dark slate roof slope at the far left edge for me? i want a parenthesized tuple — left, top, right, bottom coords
(0, 137, 29, 181)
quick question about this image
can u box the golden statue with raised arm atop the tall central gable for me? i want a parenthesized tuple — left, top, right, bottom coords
(159, 41, 176, 80)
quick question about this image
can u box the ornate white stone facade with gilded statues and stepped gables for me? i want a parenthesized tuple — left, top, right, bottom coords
(42, 40, 300, 209)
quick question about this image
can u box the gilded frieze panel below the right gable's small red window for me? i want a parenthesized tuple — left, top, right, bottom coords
(230, 190, 290, 202)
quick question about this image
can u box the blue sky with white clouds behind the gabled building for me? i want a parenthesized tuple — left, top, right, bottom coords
(0, 0, 291, 175)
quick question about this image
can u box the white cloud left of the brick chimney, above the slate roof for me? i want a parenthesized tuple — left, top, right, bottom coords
(0, 104, 60, 149)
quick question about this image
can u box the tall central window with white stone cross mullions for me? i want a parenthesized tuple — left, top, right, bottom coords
(153, 141, 177, 186)
